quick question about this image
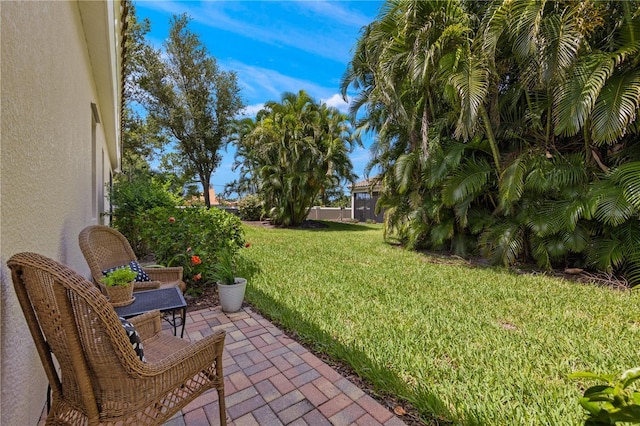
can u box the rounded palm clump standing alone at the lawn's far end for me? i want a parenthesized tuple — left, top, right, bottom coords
(231, 91, 360, 225)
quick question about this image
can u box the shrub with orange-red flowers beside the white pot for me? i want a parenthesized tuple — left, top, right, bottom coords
(142, 207, 245, 293)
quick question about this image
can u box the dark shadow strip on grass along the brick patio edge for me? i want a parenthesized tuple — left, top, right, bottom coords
(245, 286, 453, 425)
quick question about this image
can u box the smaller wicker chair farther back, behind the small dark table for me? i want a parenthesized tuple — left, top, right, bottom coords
(78, 225, 186, 293)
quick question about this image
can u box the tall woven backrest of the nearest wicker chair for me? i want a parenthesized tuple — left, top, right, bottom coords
(7, 253, 141, 424)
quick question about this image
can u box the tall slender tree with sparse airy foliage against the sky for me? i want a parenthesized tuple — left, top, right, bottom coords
(136, 15, 244, 207)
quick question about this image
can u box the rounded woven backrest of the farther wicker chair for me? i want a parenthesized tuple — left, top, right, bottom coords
(78, 225, 138, 286)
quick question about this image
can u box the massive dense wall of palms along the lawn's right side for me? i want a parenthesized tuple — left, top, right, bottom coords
(342, 0, 640, 283)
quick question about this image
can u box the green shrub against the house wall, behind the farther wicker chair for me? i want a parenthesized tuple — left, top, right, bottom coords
(109, 174, 178, 257)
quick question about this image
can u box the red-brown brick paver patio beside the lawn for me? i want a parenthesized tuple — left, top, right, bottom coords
(165, 307, 404, 426)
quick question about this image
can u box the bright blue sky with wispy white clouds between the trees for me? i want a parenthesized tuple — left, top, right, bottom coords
(135, 0, 383, 193)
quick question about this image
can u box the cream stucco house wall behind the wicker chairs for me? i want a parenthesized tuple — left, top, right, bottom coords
(0, 1, 119, 425)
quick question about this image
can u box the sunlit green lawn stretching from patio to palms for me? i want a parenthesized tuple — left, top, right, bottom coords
(235, 223, 640, 425)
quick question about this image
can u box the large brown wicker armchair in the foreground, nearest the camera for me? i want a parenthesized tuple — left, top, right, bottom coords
(7, 253, 226, 425)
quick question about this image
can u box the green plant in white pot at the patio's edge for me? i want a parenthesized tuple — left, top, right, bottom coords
(211, 248, 247, 312)
